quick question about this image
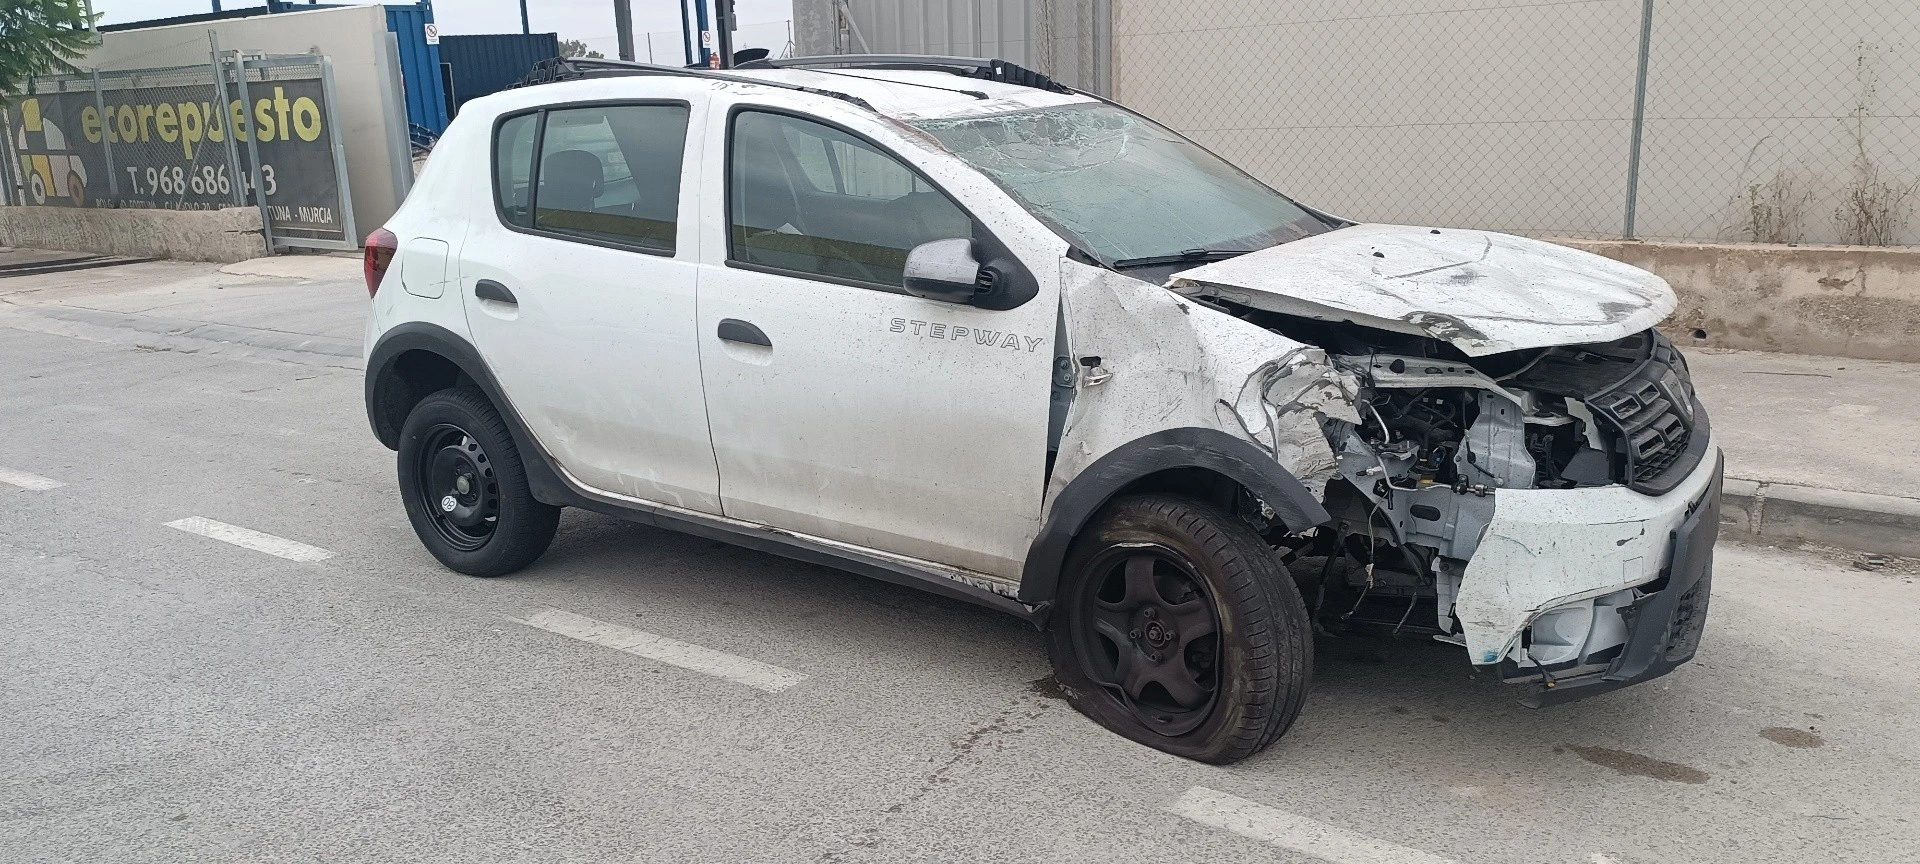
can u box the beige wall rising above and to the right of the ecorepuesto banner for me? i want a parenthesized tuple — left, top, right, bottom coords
(75, 6, 413, 240)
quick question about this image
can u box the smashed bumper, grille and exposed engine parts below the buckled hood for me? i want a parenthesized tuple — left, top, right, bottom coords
(1309, 330, 1720, 705)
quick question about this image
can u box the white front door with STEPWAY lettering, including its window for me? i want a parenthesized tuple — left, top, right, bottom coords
(697, 109, 1058, 578)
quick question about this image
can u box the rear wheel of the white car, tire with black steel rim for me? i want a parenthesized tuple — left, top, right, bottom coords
(397, 388, 561, 576)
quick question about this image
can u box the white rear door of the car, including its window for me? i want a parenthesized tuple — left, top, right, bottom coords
(459, 94, 720, 513)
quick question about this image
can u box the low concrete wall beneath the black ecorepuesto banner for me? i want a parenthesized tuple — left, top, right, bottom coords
(0, 207, 267, 261)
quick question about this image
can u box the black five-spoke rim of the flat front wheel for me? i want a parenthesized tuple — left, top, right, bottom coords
(1062, 543, 1219, 735)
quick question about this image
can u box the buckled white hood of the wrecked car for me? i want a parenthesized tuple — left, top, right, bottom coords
(1167, 225, 1674, 357)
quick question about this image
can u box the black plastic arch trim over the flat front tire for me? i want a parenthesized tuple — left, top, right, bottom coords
(1020, 426, 1331, 605)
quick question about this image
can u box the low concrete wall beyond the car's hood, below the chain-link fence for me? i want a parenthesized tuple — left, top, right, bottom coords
(1555, 240, 1920, 361)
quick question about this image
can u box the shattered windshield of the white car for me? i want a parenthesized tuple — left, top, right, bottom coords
(914, 104, 1331, 263)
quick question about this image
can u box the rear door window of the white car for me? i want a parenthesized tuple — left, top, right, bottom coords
(534, 106, 687, 253)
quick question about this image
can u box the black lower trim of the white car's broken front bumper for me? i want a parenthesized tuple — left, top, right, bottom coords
(1523, 457, 1722, 708)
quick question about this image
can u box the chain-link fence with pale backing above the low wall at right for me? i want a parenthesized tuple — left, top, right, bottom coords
(1114, 0, 1920, 246)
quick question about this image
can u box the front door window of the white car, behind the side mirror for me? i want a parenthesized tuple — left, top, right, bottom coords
(728, 111, 973, 290)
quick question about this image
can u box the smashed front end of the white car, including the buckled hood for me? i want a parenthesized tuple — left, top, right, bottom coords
(1136, 225, 1720, 705)
